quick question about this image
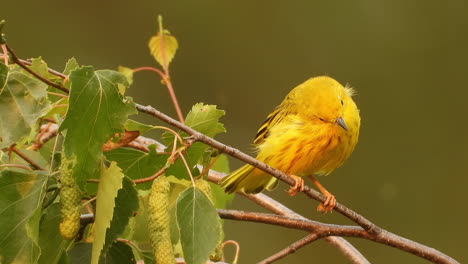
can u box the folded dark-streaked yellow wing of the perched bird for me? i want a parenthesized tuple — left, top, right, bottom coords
(254, 96, 293, 146)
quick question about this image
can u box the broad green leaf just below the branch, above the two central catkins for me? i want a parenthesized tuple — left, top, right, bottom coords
(105, 145, 168, 189)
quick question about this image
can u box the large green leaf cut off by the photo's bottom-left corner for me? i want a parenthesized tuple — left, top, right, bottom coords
(0, 171, 47, 263)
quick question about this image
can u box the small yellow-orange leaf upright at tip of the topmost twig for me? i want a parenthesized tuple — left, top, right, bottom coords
(148, 16, 179, 68)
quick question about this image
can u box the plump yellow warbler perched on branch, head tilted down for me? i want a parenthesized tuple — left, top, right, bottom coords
(220, 76, 361, 212)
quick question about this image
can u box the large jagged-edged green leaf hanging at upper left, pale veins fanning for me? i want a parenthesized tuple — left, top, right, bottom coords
(60, 66, 136, 189)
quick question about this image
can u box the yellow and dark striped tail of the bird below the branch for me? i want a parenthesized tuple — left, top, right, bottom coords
(220, 164, 278, 193)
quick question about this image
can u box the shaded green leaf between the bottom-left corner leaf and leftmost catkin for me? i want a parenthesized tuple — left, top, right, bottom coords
(38, 203, 72, 264)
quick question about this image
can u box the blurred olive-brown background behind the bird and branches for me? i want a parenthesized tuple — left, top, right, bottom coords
(0, 0, 468, 263)
